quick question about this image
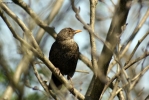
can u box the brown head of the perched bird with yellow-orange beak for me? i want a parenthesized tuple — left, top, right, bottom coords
(56, 28, 81, 41)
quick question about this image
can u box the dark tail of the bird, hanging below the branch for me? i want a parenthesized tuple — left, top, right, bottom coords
(49, 74, 62, 89)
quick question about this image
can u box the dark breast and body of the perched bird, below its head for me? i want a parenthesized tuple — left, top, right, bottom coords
(49, 39, 79, 77)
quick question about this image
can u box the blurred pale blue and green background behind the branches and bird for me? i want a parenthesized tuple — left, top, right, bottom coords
(0, 0, 149, 100)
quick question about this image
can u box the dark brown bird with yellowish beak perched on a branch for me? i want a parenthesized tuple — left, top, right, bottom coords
(49, 28, 81, 88)
